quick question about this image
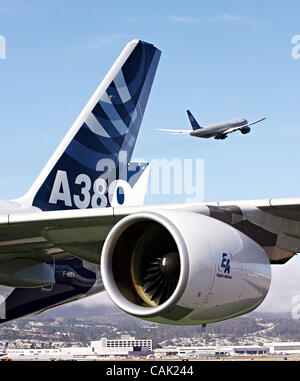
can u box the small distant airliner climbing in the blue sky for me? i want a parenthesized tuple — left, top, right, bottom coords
(158, 110, 266, 140)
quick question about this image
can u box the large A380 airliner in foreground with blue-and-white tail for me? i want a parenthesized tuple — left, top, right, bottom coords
(0, 40, 300, 325)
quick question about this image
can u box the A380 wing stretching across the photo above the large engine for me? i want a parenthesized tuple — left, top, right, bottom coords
(0, 198, 300, 264)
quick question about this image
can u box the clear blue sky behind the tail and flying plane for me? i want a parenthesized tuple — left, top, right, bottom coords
(0, 0, 300, 312)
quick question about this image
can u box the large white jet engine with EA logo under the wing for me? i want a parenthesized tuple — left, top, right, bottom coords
(101, 210, 271, 325)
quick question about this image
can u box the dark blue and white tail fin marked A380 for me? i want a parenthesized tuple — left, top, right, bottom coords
(22, 40, 161, 210)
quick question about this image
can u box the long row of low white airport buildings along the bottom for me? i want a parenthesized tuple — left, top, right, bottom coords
(7, 335, 300, 360)
